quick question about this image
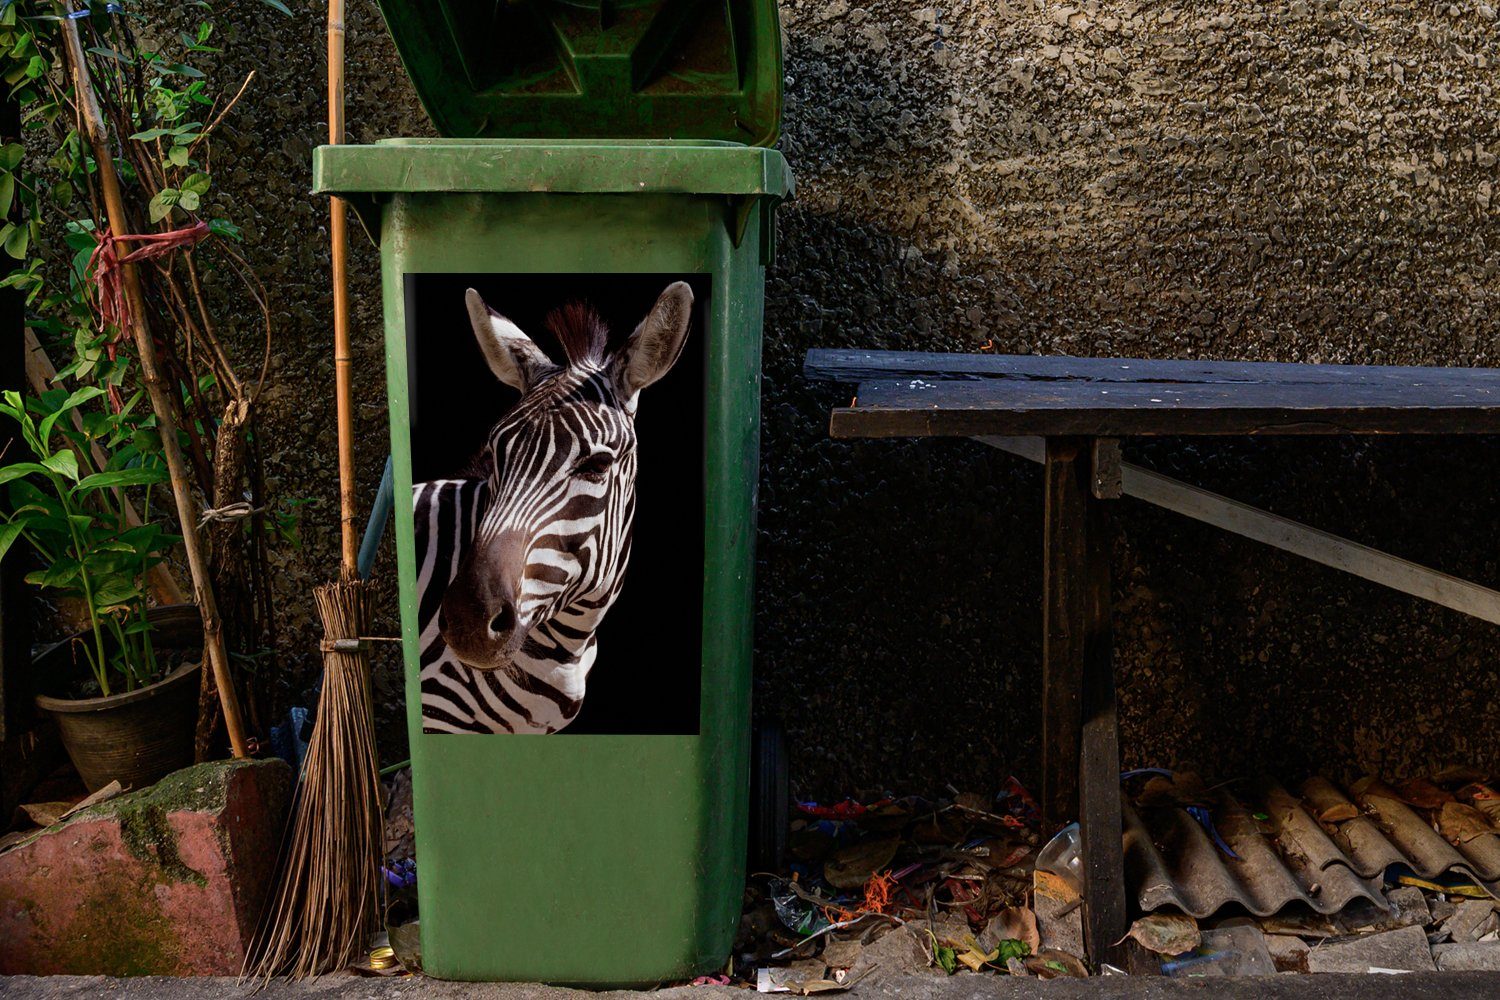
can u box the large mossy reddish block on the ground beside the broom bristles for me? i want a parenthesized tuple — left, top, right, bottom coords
(0, 760, 291, 976)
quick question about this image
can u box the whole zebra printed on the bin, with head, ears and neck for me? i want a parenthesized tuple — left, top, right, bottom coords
(413, 282, 693, 733)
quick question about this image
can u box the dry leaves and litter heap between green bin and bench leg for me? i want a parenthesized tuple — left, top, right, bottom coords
(735, 778, 1068, 993)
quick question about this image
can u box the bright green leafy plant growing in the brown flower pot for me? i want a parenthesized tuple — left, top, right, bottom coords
(0, 385, 179, 694)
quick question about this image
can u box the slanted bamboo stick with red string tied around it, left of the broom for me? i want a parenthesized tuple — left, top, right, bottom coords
(62, 7, 248, 757)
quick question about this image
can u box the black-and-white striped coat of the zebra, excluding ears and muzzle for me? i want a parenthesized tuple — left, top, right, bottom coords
(413, 370, 635, 733)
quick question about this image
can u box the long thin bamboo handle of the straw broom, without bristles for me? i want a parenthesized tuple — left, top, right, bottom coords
(329, 0, 360, 580)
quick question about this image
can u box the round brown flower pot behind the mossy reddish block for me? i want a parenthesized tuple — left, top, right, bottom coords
(33, 604, 203, 792)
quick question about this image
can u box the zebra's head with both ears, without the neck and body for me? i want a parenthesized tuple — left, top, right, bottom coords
(438, 282, 693, 670)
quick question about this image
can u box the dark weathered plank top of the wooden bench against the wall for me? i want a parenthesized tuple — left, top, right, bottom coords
(804, 351, 1500, 438)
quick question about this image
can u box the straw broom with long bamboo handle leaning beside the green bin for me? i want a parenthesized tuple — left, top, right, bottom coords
(246, 0, 384, 978)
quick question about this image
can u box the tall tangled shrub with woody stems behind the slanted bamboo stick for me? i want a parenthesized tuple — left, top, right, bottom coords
(0, 0, 291, 743)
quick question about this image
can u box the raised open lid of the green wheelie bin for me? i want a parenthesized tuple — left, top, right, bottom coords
(380, 0, 782, 145)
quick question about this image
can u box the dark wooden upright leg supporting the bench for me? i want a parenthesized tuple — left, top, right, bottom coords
(1041, 438, 1125, 963)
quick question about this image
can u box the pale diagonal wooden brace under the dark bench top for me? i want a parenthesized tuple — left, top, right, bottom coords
(975, 436, 1500, 625)
